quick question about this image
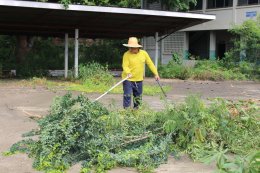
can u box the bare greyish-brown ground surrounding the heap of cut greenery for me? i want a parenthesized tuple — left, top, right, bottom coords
(0, 79, 260, 173)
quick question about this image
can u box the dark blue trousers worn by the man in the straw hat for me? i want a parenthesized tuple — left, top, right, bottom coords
(123, 80, 143, 109)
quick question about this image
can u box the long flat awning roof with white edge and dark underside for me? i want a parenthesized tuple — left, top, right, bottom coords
(0, 0, 215, 38)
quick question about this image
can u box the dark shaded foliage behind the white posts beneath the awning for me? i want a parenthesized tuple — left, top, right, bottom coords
(0, 36, 125, 77)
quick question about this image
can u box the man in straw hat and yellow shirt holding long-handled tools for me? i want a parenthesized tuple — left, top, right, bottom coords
(122, 37, 160, 109)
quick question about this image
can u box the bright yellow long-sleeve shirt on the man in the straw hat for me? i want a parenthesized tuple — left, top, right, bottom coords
(122, 49, 158, 81)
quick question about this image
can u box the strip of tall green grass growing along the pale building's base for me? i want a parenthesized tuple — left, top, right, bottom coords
(153, 60, 260, 81)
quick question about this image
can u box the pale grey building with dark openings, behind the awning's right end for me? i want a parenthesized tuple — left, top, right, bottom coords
(143, 0, 260, 64)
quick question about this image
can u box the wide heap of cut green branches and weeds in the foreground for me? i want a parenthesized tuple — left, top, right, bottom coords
(5, 94, 260, 173)
